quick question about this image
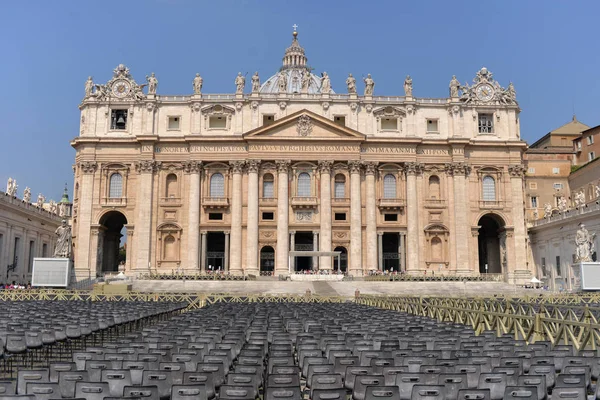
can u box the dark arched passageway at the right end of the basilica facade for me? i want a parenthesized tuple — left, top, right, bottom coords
(477, 214, 506, 274)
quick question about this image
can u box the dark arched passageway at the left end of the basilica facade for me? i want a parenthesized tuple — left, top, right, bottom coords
(98, 211, 127, 272)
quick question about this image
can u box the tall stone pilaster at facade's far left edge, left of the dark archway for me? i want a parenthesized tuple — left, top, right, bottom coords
(75, 161, 98, 280)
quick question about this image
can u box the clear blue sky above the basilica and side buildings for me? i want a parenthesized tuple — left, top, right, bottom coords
(0, 0, 600, 199)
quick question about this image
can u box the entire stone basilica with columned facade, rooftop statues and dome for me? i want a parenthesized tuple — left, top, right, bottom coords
(72, 32, 531, 282)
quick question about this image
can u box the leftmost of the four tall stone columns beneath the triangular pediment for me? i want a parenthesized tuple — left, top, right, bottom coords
(246, 160, 260, 274)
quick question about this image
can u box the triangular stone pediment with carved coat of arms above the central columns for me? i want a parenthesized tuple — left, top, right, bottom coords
(243, 110, 365, 141)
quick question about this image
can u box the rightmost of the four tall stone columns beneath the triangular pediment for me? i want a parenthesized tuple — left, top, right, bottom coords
(348, 161, 363, 276)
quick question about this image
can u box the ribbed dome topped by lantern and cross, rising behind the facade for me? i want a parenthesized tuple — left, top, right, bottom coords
(259, 31, 334, 94)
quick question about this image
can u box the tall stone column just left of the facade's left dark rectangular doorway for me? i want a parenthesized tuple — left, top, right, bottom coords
(183, 161, 202, 271)
